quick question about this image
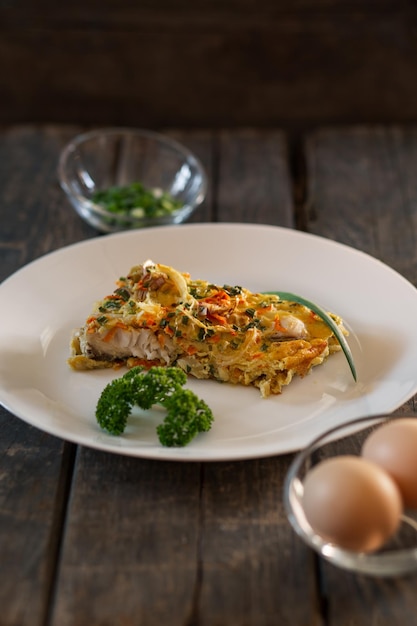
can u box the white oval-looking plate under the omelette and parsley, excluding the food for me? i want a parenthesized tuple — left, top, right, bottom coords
(0, 224, 417, 461)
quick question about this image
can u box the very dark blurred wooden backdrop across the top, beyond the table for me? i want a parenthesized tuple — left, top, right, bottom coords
(0, 0, 417, 131)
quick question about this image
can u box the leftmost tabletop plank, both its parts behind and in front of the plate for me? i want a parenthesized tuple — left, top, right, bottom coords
(0, 127, 88, 626)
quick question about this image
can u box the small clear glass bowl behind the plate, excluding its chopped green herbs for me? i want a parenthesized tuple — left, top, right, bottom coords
(58, 128, 207, 233)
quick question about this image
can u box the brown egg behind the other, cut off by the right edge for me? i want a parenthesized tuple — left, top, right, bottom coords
(362, 417, 417, 508)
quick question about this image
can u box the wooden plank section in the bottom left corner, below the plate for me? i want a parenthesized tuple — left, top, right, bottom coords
(0, 408, 72, 626)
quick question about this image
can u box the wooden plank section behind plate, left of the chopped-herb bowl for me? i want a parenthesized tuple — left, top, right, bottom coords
(0, 126, 95, 280)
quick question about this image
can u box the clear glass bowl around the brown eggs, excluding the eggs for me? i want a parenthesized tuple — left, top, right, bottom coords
(284, 415, 417, 577)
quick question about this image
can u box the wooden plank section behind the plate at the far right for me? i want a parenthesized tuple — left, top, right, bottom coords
(306, 127, 417, 285)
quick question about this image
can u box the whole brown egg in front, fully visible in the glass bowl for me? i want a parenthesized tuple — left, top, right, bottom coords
(302, 456, 402, 552)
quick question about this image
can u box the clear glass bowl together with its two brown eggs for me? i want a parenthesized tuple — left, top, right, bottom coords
(284, 415, 417, 577)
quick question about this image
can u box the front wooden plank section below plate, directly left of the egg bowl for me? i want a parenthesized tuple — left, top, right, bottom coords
(197, 455, 320, 626)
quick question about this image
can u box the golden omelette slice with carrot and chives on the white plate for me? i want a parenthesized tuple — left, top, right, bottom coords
(68, 261, 348, 397)
